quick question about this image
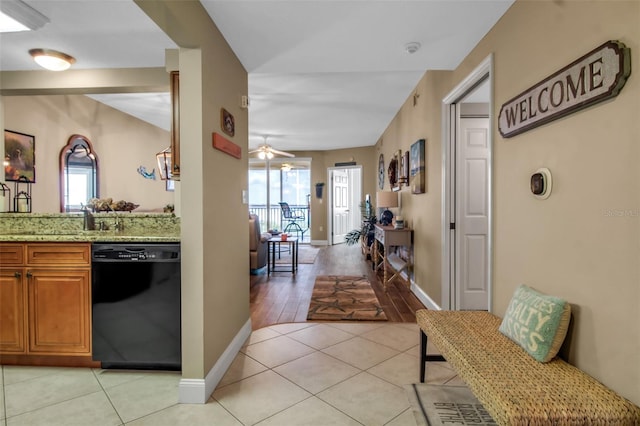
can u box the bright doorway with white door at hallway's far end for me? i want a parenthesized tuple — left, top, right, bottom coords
(327, 166, 363, 245)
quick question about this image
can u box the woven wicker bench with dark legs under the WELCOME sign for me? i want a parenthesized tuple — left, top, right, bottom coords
(416, 310, 640, 426)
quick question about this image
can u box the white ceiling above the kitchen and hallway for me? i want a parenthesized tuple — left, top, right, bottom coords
(0, 0, 514, 150)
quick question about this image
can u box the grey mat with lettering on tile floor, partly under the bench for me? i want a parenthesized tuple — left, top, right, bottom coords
(404, 383, 497, 426)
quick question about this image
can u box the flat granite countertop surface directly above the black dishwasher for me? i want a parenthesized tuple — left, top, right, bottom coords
(0, 230, 180, 243)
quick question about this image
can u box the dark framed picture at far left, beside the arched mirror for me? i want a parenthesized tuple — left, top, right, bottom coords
(4, 130, 36, 183)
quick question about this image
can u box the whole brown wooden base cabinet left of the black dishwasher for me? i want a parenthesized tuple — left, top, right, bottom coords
(0, 243, 91, 360)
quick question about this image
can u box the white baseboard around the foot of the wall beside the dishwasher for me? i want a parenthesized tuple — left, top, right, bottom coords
(178, 318, 251, 404)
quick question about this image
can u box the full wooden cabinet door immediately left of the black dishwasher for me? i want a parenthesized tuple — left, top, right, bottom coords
(27, 268, 91, 355)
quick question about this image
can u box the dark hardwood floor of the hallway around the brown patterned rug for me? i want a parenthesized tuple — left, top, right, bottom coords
(250, 244, 424, 330)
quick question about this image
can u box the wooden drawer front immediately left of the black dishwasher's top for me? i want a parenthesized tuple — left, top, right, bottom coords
(27, 243, 91, 266)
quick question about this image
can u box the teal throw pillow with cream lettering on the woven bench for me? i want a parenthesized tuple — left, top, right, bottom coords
(500, 285, 571, 362)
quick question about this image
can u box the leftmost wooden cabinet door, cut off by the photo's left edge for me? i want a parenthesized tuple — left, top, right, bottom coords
(0, 268, 27, 354)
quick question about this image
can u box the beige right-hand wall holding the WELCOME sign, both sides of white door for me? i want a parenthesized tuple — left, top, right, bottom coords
(378, 0, 640, 404)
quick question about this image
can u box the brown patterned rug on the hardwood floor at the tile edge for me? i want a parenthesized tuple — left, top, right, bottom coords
(307, 275, 387, 321)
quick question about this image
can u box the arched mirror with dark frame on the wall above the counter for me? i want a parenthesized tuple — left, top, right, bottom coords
(60, 135, 99, 212)
